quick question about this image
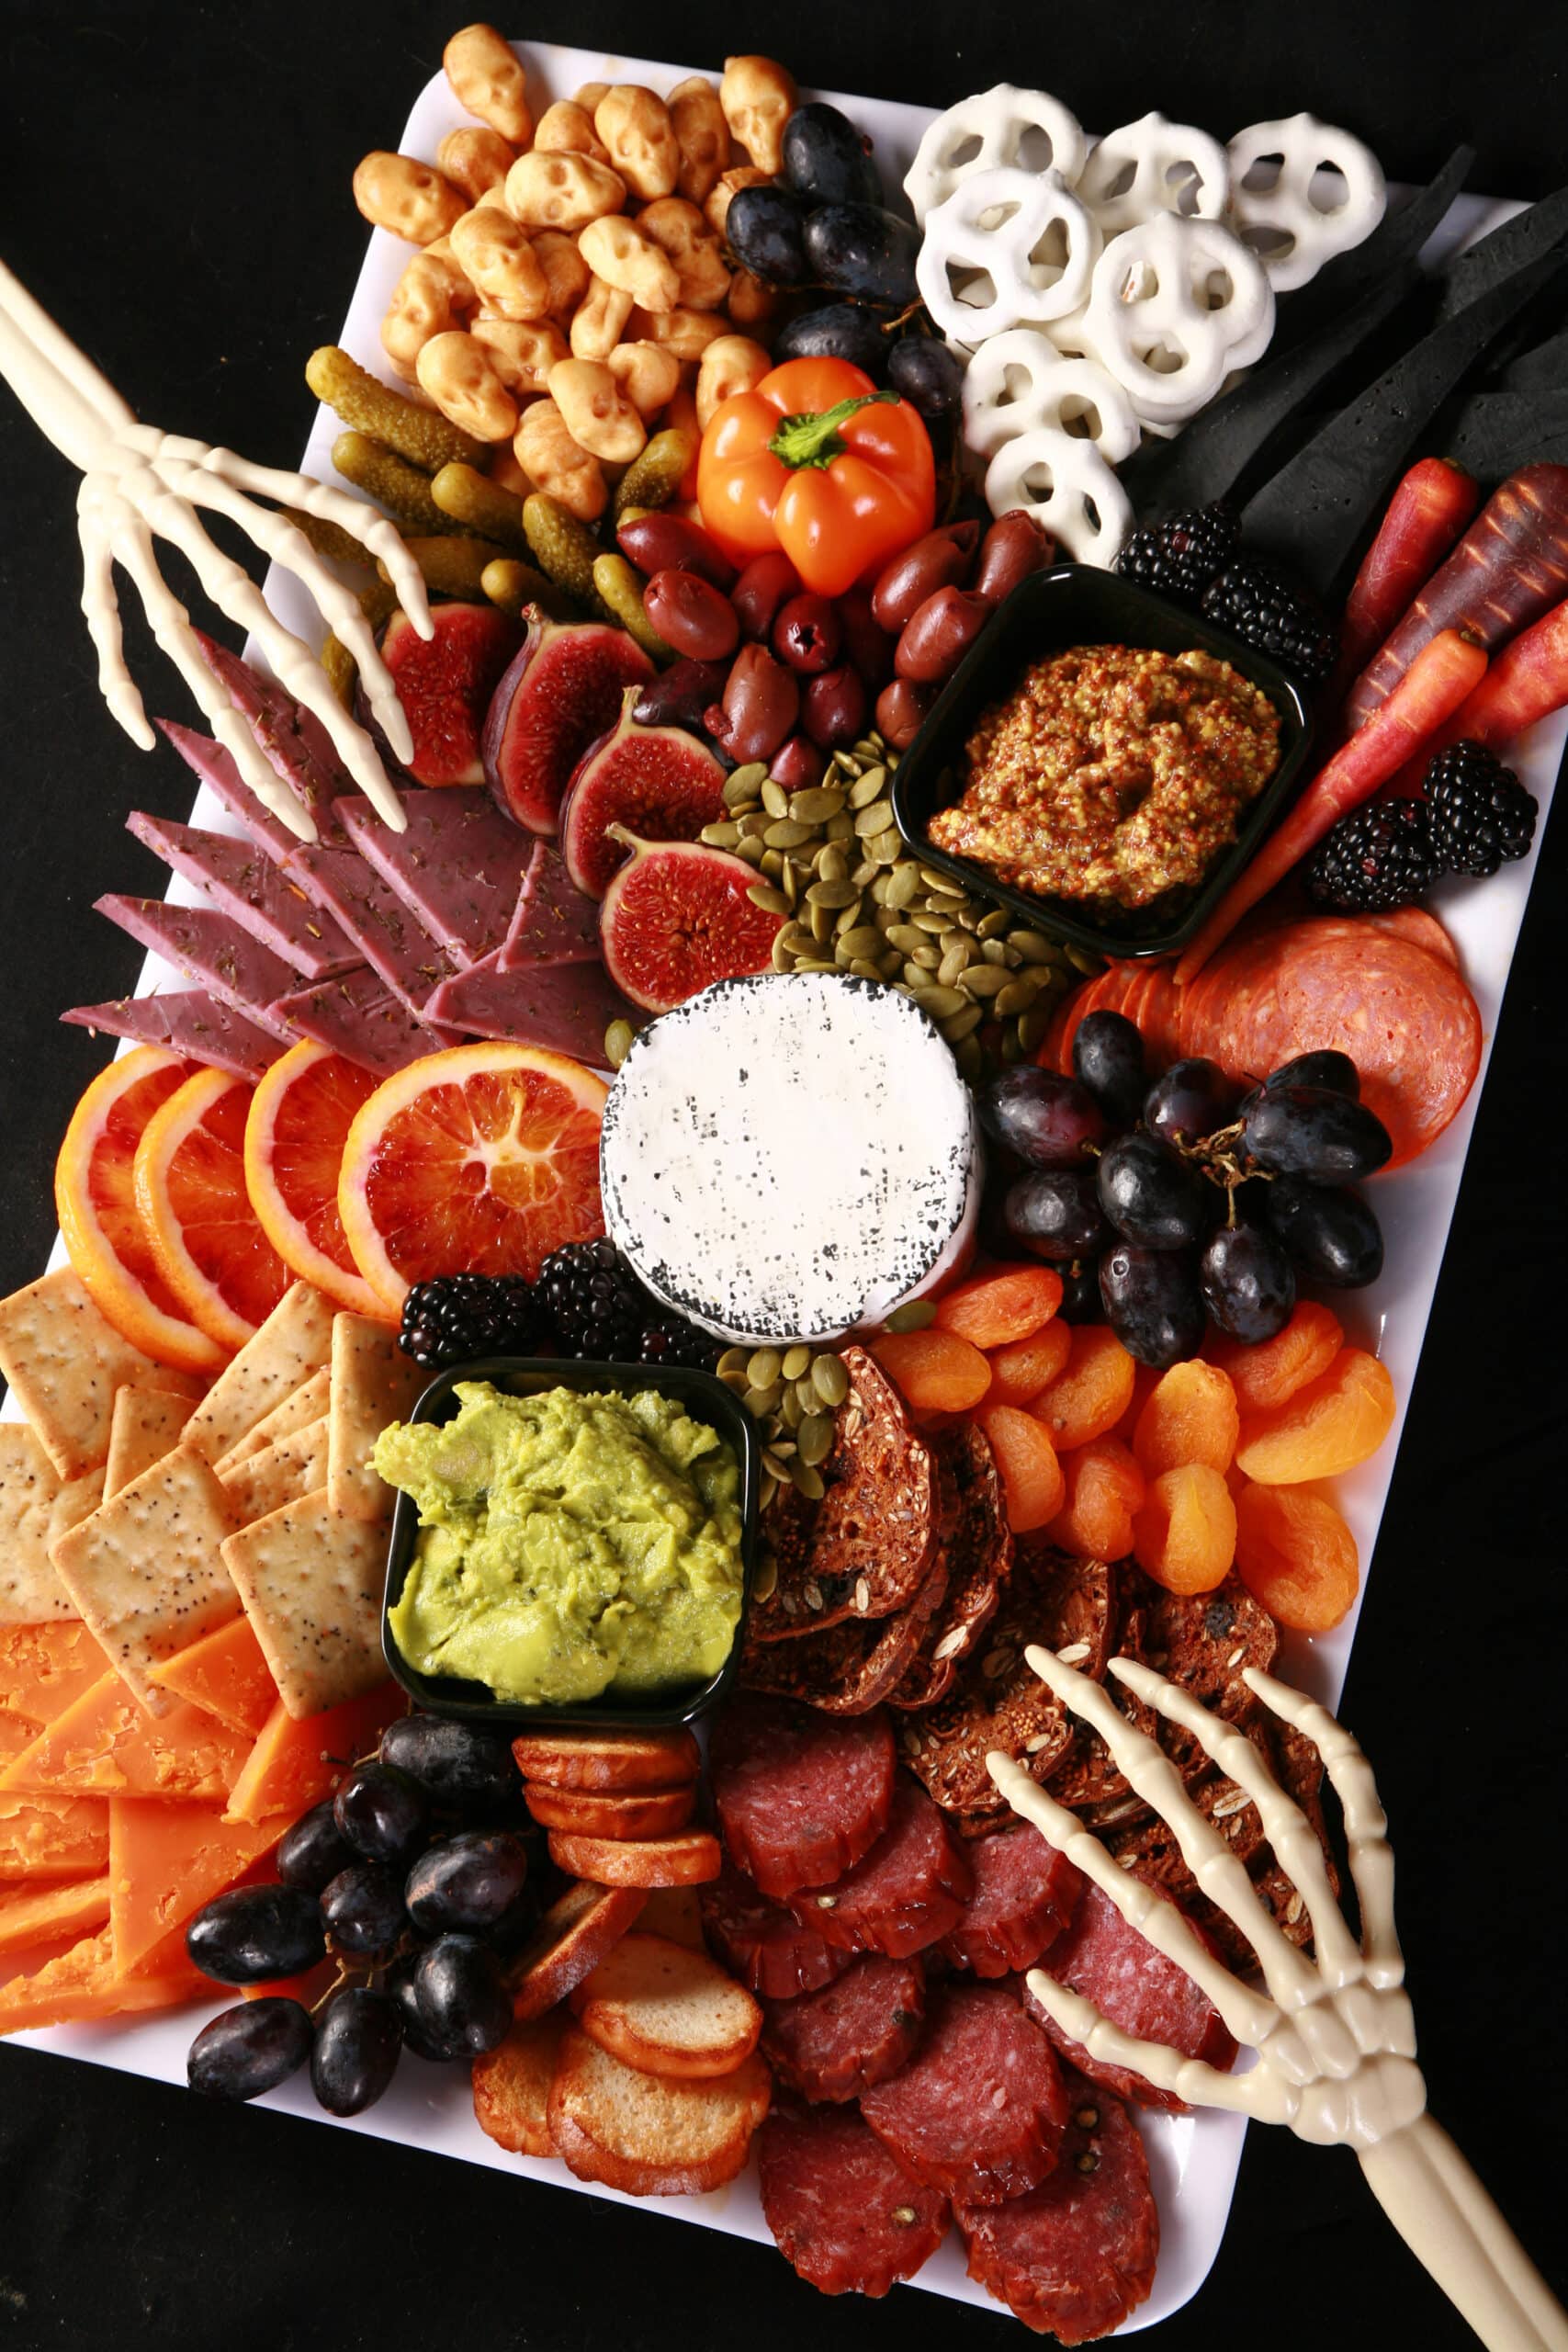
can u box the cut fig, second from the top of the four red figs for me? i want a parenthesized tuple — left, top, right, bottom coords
(484, 609, 653, 832)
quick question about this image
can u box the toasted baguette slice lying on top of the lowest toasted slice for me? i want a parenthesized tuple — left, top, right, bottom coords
(571, 1933, 761, 2079)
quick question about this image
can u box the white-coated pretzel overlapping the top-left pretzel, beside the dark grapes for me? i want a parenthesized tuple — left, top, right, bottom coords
(915, 164, 1100, 344)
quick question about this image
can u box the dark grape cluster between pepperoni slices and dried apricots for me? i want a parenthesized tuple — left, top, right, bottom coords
(980, 1012, 1392, 1371)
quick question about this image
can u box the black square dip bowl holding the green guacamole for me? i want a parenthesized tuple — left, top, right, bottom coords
(381, 1355, 761, 1738)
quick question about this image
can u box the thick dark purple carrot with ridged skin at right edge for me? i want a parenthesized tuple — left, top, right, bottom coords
(1342, 466, 1568, 734)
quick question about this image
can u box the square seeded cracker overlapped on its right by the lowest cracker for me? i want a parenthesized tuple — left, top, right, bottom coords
(51, 1446, 235, 1714)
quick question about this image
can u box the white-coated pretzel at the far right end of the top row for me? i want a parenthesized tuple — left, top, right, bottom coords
(1229, 115, 1387, 294)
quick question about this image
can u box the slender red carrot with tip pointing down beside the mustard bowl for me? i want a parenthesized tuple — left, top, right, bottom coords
(1176, 628, 1485, 986)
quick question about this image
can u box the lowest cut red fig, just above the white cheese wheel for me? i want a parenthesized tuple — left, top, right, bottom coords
(600, 826, 783, 1013)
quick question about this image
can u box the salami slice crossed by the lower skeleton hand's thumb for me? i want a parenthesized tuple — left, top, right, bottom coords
(1018, 1879, 1236, 2114)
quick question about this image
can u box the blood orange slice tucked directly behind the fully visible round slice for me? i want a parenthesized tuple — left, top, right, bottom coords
(244, 1037, 386, 1315)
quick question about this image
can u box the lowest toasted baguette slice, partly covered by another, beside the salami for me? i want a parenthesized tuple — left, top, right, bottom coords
(550, 2025, 771, 2197)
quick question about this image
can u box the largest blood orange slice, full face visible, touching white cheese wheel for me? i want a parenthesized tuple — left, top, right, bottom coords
(339, 1045, 609, 1315)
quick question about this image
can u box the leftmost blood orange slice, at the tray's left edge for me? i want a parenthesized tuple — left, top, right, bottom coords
(54, 1045, 226, 1371)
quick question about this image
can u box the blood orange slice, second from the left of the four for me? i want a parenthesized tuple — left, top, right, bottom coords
(136, 1070, 289, 1350)
